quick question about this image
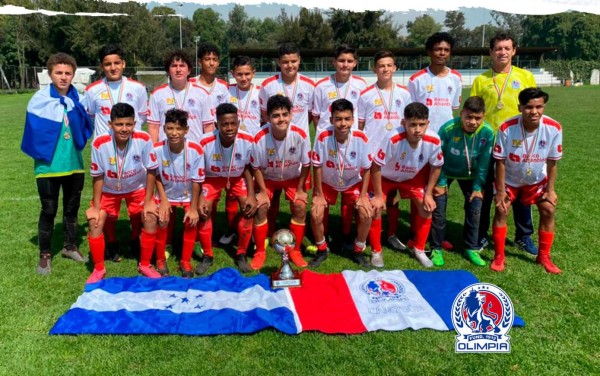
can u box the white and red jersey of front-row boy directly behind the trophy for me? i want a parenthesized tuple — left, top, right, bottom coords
(251, 123, 311, 181)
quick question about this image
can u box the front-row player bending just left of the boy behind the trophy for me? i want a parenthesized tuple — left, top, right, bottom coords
(195, 103, 256, 275)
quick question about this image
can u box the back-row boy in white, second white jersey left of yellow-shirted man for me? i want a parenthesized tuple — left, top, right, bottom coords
(358, 51, 411, 249)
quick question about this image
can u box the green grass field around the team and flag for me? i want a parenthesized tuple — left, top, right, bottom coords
(0, 87, 600, 375)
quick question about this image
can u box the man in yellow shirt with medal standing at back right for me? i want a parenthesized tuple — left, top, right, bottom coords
(471, 32, 538, 254)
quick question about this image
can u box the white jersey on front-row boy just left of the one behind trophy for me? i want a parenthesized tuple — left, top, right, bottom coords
(200, 129, 254, 178)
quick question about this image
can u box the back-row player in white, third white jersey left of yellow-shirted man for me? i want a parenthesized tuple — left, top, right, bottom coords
(312, 44, 367, 134)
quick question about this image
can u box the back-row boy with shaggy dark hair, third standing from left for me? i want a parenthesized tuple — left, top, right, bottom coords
(148, 50, 214, 143)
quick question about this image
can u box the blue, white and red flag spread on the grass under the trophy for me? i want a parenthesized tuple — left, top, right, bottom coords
(50, 268, 524, 335)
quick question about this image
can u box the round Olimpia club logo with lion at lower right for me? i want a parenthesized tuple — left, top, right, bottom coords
(452, 283, 515, 353)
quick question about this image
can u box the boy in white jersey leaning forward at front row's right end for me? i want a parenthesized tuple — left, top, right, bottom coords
(490, 88, 562, 274)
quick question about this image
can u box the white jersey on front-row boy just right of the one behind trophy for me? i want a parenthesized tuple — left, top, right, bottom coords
(312, 126, 371, 192)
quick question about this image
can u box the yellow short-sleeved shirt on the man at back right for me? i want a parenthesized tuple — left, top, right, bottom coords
(471, 66, 536, 131)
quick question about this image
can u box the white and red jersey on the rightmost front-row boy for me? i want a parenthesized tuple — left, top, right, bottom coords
(493, 115, 562, 187)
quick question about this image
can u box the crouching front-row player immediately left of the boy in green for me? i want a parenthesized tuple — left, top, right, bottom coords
(369, 102, 444, 268)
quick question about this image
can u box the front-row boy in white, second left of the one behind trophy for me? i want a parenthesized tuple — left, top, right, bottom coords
(148, 109, 205, 278)
